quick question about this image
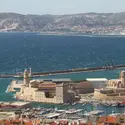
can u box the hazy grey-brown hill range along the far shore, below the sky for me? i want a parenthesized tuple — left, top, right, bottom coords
(0, 12, 125, 34)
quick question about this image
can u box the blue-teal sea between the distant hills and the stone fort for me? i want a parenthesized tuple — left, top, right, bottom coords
(0, 32, 125, 112)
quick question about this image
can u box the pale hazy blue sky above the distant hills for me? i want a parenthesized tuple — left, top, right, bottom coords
(0, 0, 125, 14)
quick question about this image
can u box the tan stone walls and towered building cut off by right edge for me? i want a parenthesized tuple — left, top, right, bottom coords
(94, 71, 125, 100)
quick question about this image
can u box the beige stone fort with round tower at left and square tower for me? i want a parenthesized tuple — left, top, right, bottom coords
(16, 70, 75, 104)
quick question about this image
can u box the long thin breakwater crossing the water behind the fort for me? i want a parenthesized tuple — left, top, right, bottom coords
(0, 64, 125, 78)
